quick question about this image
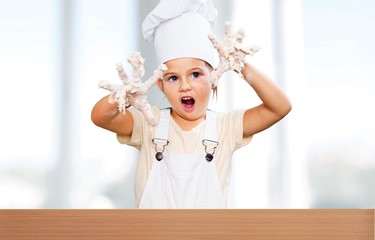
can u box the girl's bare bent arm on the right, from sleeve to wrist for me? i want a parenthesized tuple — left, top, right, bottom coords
(241, 63, 292, 137)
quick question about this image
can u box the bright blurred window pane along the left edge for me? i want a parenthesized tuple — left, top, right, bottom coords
(0, 0, 56, 208)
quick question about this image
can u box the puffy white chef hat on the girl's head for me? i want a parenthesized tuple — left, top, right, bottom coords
(142, 0, 217, 67)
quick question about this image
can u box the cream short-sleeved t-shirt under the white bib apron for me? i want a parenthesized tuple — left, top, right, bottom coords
(117, 108, 252, 207)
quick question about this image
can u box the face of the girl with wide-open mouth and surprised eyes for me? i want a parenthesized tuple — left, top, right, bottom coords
(158, 58, 212, 128)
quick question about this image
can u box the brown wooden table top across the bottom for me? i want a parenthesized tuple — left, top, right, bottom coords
(0, 209, 375, 240)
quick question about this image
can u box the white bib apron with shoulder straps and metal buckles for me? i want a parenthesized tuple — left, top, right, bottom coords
(139, 109, 226, 209)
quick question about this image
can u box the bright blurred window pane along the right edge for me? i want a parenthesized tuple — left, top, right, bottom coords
(303, 0, 375, 208)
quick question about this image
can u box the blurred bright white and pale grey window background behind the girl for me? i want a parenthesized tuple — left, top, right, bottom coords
(0, 0, 375, 208)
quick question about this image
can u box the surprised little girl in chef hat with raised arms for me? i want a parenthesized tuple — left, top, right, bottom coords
(92, 0, 291, 208)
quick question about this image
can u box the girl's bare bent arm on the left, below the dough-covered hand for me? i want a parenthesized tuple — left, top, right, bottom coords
(91, 95, 134, 136)
